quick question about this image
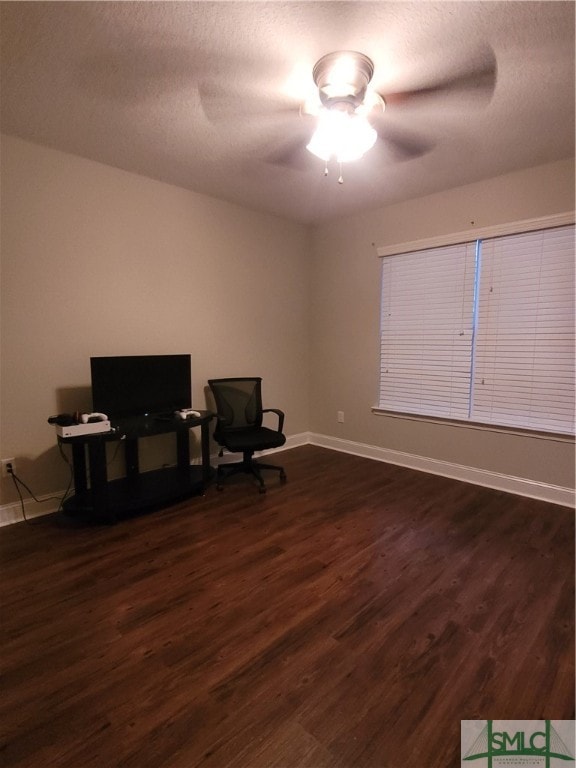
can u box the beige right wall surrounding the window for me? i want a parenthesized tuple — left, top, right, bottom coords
(310, 161, 574, 488)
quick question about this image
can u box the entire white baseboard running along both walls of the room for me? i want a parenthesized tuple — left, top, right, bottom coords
(0, 432, 576, 527)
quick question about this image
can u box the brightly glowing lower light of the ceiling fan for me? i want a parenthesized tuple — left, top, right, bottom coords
(306, 109, 377, 163)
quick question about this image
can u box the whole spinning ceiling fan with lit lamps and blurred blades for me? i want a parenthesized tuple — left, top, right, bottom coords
(200, 45, 497, 183)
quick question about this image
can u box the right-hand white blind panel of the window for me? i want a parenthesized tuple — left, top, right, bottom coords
(471, 227, 574, 432)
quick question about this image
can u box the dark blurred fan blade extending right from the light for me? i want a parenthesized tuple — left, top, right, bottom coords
(382, 46, 498, 106)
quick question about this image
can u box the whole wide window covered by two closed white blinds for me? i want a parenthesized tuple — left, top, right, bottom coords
(379, 225, 574, 434)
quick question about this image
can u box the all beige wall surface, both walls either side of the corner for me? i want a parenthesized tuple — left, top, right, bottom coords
(0, 137, 574, 504)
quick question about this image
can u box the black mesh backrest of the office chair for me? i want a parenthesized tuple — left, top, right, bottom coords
(208, 378, 262, 429)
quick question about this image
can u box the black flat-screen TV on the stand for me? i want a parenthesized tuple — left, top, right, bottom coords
(90, 355, 192, 417)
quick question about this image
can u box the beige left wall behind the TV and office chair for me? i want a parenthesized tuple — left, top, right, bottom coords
(0, 137, 310, 503)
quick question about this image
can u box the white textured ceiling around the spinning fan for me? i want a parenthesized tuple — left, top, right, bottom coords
(0, 1, 575, 222)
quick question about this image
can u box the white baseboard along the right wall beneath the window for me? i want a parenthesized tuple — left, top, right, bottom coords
(309, 433, 576, 507)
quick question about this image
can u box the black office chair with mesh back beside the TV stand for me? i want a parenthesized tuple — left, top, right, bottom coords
(208, 377, 286, 493)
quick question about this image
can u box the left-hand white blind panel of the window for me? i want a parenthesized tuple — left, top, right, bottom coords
(380, 244, 475, 418)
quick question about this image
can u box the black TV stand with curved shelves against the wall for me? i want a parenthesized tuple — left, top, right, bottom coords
(58, 411, 214, 522)
